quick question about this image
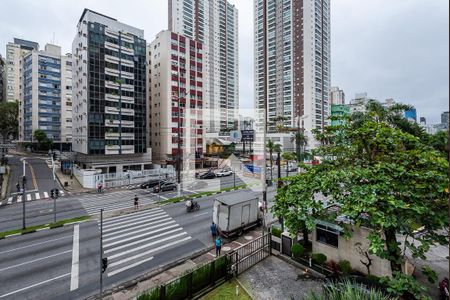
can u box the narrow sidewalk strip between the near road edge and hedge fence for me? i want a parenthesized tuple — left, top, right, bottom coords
(103, 229, 268, 300)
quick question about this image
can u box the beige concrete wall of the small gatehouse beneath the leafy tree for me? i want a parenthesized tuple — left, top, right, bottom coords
(312, 227, 391, 276)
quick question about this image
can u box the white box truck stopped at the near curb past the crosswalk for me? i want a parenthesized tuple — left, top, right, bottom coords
(213, 191, 263, 238)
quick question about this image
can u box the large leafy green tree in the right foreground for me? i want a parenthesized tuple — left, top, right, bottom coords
(273, 118, 448, 272)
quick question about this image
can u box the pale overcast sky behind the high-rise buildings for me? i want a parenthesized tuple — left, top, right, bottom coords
(0, 0, 449, 123)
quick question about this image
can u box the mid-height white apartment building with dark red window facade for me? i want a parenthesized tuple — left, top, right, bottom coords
(147, 30, 206, 169)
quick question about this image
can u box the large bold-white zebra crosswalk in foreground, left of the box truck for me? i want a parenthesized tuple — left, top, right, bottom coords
(99, 207, 192, 277)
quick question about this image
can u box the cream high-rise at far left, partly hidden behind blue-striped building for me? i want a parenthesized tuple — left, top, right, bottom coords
(4, 38, 39, 102)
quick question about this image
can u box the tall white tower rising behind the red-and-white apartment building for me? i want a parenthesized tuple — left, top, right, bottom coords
(168, 0, 239, 133)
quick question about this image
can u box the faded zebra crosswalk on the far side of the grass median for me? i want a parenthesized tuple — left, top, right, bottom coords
(79, 190, 155, 215)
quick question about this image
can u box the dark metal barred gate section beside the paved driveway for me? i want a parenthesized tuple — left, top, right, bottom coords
(228, 233, 272, 275)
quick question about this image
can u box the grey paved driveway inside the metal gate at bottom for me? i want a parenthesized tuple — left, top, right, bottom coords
(238, 255, 322, 300)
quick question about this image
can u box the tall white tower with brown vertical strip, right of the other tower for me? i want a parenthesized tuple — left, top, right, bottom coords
(254, 0, 331, 146)
